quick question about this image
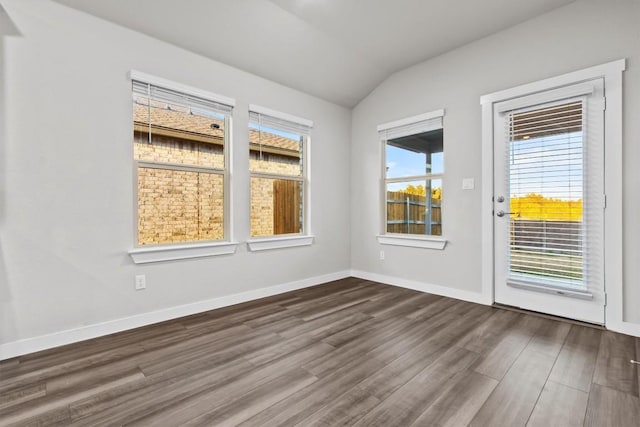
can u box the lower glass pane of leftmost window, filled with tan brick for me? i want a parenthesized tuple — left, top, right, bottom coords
(138, 167, 224, 245)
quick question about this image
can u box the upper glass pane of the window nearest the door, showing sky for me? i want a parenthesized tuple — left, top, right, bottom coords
(385, 129, 444, 178)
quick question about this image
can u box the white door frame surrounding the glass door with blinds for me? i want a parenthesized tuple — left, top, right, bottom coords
(480, 59, 640, 336)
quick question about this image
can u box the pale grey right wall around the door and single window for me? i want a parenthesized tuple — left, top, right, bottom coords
(351, 0, 640, 323)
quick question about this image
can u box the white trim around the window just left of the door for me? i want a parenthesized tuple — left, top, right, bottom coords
(376, 109, 448, 250)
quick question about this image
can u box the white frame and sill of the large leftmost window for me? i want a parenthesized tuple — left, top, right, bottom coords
(129, 70, 238, 264)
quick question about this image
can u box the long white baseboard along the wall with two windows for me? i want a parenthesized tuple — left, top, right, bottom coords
(0, 270, 351, 360)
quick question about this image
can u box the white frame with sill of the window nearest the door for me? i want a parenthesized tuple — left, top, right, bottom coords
(376, 109, 447, 250)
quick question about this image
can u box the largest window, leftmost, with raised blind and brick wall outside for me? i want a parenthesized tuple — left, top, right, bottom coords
(132, 72, 233, 246)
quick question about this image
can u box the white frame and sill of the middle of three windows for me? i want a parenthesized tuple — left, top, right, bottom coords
(247, 104, 314, 252)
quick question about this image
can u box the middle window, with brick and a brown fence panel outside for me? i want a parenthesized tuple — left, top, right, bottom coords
(249, 105, 312, 237)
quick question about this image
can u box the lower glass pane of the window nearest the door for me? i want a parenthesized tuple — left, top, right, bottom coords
(386, 179, 442, 236)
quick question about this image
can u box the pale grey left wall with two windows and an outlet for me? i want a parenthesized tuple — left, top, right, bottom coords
(0, 0, 351, 352)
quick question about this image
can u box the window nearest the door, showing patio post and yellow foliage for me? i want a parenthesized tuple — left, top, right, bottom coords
(378, 110, 444, 236)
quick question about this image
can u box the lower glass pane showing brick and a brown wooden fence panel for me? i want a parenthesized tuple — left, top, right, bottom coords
(251, 177, 303, 237)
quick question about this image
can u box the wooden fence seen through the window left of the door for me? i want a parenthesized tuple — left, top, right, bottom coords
(387, 191, 442, 236)
